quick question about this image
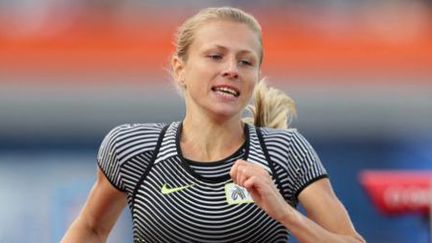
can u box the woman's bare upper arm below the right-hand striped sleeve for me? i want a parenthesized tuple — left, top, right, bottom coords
(298, 178, 361, 238)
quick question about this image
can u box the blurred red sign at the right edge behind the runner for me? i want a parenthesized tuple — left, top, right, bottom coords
(360, 171, 432, 215)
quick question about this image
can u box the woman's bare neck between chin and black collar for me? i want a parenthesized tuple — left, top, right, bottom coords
(180, 113, 245, 162)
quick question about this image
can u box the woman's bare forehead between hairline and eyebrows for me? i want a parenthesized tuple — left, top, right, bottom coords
(190, 20, 261, 56)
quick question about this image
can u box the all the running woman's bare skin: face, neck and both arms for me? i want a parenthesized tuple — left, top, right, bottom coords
(62, 20, 364, 242)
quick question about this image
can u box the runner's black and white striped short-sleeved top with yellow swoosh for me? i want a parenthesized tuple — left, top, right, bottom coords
(98, 122, 327, 242)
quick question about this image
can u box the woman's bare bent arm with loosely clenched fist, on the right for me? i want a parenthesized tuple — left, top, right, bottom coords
(230, 160, 365, 243)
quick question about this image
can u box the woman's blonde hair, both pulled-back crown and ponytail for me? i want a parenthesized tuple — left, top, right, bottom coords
(173, 7, 296, 128)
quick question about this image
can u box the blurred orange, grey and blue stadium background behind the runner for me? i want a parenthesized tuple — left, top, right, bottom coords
(0, 0, 432, 243)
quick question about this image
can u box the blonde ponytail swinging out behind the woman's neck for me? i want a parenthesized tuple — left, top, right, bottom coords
(243, 80, 297, 129)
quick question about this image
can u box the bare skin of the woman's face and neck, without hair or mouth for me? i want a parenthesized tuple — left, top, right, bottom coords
(173, 21, 261, 161)
